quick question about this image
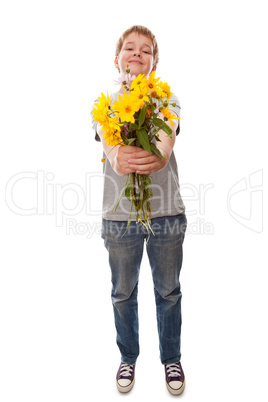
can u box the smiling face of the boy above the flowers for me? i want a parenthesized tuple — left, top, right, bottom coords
(114, 32, 156, 77)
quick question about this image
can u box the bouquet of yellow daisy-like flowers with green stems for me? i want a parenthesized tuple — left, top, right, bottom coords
(93, 66, 179, 231)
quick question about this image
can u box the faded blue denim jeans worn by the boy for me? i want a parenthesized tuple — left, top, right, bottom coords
(102, 214, 187, 364)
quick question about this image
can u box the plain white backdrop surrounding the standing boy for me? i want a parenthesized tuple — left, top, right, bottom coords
(0, 0, 268, 402)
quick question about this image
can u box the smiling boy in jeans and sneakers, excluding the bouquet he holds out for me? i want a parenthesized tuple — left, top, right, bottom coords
(93, 26, 186, 395)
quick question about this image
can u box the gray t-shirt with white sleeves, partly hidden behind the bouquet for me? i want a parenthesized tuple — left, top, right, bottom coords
(91, 92, 185, 221)
